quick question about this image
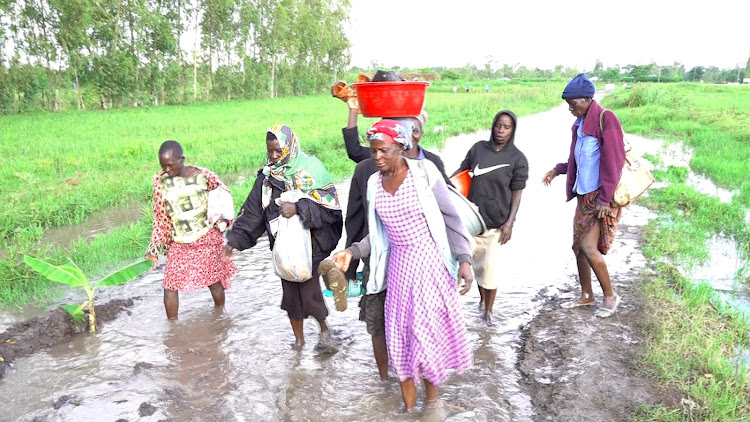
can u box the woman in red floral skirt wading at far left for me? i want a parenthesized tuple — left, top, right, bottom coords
(146, 141, 237, 319)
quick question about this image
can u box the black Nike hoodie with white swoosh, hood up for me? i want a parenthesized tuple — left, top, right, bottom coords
(456, 110, 529, 229)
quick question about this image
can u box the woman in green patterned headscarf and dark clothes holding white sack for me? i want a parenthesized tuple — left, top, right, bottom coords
(224, 125, 343, 353)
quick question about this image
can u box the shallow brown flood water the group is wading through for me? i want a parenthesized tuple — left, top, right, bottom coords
(0, 99, 740, 421)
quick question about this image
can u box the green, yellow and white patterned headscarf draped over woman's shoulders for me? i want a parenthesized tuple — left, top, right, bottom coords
(262, 125, 341, 209)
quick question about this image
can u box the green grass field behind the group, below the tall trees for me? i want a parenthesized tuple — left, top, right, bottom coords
(0, 81, 564, 305)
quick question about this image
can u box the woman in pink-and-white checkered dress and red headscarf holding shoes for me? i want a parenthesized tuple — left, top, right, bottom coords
(334, 119, 472, 410)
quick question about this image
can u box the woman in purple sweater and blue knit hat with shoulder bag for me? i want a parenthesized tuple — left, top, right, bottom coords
(542, 73, 625, 318)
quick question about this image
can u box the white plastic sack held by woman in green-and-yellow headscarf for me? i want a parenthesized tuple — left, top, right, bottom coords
(273, 214, 312, 282)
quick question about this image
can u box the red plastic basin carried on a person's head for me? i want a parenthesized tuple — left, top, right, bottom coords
(352, 81, 430, 117)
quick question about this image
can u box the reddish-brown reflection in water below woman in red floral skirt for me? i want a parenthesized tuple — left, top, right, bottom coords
(162, 309, 234, 420)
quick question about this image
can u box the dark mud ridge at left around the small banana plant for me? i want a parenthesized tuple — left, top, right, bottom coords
(0, 298, 138, 379)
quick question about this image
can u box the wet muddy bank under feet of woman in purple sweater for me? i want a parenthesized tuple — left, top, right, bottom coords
(518, 226, 679, 421)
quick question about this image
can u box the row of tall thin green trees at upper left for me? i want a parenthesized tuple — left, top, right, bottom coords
(0, 0, 350, 113)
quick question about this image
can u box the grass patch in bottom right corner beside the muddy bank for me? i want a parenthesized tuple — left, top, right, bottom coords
(637, 264, 750, 421)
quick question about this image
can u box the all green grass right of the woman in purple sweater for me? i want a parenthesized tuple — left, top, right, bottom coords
(603, 84, 750, 421)
